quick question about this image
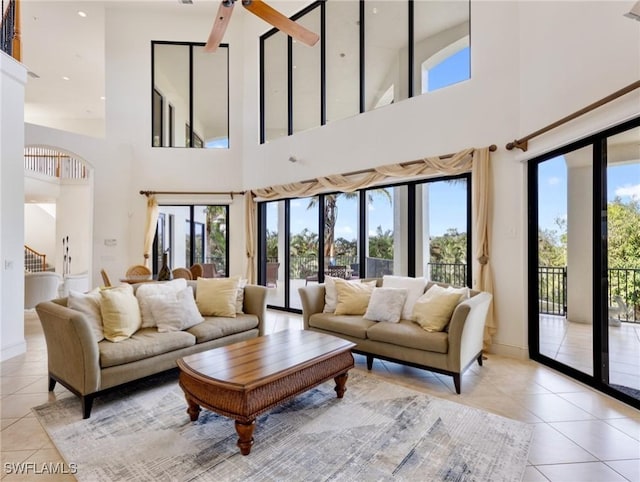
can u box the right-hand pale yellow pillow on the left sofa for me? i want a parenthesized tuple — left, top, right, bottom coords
(196, 276, 240, 318)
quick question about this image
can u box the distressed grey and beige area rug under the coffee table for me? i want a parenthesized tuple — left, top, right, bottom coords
(33, 370, 532, 482)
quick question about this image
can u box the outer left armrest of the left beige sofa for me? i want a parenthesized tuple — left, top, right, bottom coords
(36, 301, 101, 395)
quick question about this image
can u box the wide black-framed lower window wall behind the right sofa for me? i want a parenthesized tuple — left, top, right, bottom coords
(258, 174, 471, 311)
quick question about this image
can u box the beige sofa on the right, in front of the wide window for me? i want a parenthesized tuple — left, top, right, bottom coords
(299, 280, 492, 394)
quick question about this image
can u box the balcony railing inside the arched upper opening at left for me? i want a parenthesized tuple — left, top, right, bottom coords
(24, 146, 89, 179)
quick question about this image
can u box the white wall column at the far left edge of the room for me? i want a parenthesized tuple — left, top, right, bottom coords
(0, 52, 27, 360)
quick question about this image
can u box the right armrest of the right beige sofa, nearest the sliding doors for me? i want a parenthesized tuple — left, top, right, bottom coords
(447, 292, 492, 372)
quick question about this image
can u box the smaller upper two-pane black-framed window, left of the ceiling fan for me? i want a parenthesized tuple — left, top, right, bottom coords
(151, 42, 229, 149)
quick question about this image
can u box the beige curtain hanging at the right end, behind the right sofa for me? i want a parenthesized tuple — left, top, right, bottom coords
(471, 148, 497, 350)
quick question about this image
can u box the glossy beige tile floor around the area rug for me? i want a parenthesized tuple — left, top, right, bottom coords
(0, 311, 640, 482)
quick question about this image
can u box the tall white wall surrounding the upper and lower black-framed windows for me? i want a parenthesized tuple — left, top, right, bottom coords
(17, 1, 640, 362)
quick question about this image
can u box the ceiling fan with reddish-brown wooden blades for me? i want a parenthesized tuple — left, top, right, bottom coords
(204, 0, 320, 52)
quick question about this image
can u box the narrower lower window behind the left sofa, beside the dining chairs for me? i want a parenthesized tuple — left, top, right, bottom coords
(153, 205, 229, 274)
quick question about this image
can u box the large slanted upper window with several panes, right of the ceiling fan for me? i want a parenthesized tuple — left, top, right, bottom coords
(260, 0, 471, 143)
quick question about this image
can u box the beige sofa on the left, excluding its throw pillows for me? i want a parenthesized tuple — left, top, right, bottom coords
(36, 281, 267, 418)
